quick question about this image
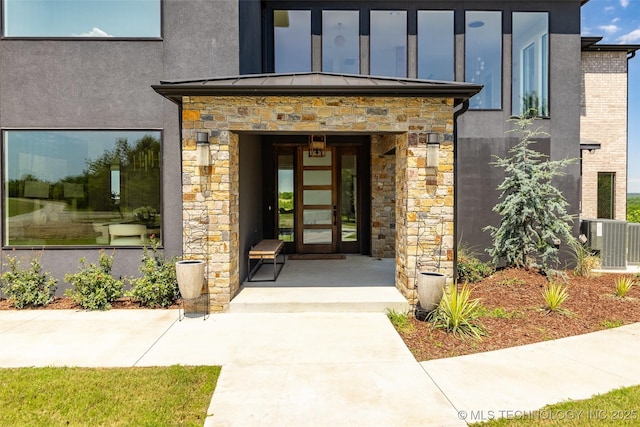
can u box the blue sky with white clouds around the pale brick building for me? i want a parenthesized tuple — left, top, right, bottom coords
(582, 0, 640, 193)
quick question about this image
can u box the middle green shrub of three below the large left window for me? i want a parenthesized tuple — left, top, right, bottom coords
(64, 251, 123, 310)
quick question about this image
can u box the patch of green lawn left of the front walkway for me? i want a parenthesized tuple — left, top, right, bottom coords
(0, 365, 220, 426)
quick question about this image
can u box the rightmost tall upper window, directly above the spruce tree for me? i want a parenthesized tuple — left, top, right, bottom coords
(511, 12, 549, 116)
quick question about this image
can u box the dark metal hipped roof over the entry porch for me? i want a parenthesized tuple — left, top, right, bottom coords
(151, 72, 482, 105)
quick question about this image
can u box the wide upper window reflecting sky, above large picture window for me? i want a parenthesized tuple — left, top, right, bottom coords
(2, 0, 161, 38)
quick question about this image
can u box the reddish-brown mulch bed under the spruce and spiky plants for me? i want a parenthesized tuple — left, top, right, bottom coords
(400, 269, 640, 361)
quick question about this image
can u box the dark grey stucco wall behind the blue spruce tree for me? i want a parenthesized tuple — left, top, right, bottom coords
(456, 26, 580, 262)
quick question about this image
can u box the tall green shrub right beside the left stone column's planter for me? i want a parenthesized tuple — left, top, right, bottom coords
(126, 239, 179, 308)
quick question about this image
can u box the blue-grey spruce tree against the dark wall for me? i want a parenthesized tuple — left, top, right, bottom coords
(484, 117, 574, 271)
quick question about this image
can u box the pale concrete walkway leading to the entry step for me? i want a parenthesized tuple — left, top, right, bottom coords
(0, 310, 640, 426)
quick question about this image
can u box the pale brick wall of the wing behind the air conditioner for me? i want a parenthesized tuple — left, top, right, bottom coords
(580, 51, 627, 220)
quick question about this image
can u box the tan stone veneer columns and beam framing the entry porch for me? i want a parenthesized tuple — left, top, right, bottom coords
(182, 96, 453, 311)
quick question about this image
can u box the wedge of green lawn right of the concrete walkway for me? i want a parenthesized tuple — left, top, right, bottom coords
(473, 386, 640, 427)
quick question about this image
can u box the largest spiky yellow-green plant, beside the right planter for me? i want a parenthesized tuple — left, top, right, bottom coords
(429, 284, 485, 339)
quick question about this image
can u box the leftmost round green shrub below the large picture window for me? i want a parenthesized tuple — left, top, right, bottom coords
(0, 256, 58, 308)
